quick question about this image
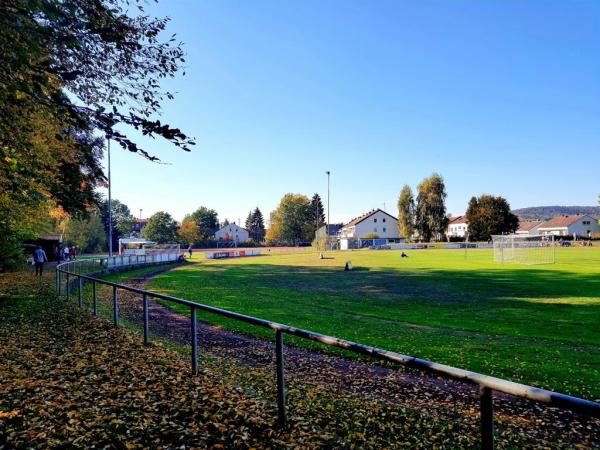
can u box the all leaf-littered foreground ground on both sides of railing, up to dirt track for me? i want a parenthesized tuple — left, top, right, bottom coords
(0, 268, 600, 449)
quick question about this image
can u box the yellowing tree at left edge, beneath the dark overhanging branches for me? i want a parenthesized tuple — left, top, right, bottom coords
(0, 111, 102, 270)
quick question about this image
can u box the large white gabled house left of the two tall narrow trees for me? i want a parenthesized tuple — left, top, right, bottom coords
(338, 209, 403, 250)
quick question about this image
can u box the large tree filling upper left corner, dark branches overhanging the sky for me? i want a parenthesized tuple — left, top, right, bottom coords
(0, 0, 193, 270)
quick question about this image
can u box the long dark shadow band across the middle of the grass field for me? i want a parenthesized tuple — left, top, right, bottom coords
(183, 264, 600, 306)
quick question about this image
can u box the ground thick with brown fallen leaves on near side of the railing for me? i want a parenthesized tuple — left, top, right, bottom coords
(0, 272, 328, 449)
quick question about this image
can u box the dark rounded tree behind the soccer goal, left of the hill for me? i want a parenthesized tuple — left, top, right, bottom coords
(467, 194, 519, 241)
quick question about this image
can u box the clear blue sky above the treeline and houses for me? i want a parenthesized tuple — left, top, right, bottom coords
(105, 0, 600, 222)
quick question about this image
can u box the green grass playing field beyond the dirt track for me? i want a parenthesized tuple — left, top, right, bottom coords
(144, 248, 600, 399)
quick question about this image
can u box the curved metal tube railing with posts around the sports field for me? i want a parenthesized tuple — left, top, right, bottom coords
(56, 255, 600, 449)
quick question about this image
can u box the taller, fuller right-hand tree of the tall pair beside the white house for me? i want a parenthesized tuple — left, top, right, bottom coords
(415, 173, 448, 241)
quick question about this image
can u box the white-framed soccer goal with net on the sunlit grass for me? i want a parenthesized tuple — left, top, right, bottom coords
(492, 234, 556, 264)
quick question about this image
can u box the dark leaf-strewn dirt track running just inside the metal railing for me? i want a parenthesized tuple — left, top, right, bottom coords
(112, 268, 600, 448)
